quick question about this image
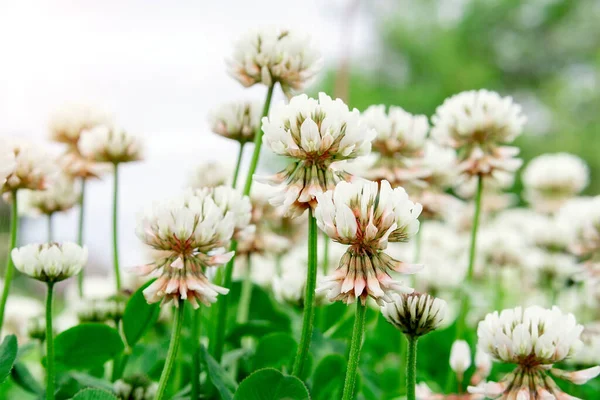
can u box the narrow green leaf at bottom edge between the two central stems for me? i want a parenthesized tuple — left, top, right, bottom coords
(312, 354, 347, 400)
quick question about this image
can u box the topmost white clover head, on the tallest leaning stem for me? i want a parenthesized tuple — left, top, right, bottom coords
(227, 27, 323, 95)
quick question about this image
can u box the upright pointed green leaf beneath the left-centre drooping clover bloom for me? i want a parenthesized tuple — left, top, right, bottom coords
(123, 280, 160, 347)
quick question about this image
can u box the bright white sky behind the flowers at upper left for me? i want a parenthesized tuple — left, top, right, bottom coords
(0, 0, 371, 276)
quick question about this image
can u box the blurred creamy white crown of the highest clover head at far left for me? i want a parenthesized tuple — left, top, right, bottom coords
(49, 104, 110, 146)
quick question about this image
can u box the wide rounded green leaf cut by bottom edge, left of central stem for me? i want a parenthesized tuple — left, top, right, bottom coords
(233, 368, 310, 400)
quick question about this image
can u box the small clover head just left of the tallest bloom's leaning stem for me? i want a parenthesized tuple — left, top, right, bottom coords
(208, 101, 262, 144)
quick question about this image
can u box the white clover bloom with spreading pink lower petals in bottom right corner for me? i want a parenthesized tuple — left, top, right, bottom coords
(469, 306, 600, 399)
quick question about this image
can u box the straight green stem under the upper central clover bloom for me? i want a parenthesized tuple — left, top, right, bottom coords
(292, 208, 318, 376)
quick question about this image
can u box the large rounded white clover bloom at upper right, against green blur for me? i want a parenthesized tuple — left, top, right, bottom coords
(431, 89, 526, 175)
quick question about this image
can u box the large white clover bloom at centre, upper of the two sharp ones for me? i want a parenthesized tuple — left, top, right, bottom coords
(262, 93, 375, 215)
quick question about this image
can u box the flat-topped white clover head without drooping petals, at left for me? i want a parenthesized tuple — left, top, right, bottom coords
(11, 242, 88, 282)
